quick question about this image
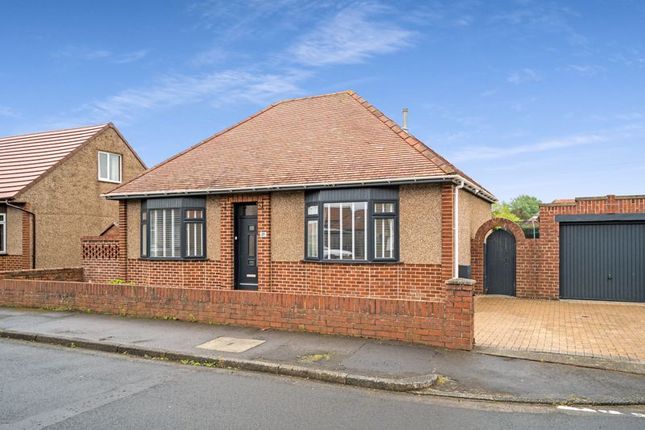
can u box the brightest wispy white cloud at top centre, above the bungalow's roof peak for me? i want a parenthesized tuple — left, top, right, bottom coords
(288, 4, 413, 66)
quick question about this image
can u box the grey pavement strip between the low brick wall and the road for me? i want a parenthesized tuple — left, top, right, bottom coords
(0, 308, 645, 404)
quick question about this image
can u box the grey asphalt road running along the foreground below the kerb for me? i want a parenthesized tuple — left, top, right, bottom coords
(0, 340, 645, 430)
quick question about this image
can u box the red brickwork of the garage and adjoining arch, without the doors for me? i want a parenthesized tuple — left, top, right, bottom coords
(471, 195, 645, 299)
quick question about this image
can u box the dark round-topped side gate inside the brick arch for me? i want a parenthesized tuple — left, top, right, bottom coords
(484, 230, 515, 296)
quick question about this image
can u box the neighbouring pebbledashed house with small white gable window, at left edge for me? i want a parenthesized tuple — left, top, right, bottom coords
(0, 124, 146, 271)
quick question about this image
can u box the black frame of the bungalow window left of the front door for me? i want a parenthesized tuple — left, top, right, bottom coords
(139, 197, 207, 260)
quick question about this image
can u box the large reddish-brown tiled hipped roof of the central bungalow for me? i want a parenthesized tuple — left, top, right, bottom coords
(108, 91, 494, 202)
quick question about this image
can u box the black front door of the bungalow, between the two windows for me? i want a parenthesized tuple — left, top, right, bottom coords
(235, 204, 258, 290)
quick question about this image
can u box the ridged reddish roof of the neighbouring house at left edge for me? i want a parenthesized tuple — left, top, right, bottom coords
(0, 124, 108, 199)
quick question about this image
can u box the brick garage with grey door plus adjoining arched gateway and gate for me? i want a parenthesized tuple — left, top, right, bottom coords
(471, 195, 645, 302)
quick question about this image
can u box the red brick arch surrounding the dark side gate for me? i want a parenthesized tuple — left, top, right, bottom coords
(470, 218, 530, 297)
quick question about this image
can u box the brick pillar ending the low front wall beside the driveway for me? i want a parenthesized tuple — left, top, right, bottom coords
(443, 278, 475, 351)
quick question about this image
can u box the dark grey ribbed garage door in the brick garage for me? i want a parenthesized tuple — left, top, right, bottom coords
(560, 222, 645, 302)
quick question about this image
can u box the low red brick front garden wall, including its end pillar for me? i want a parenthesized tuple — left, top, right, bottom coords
(0, 280, 473, 350)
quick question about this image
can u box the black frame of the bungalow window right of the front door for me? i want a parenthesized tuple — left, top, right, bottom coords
(304, 187, 399, 264)
